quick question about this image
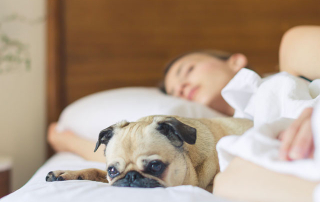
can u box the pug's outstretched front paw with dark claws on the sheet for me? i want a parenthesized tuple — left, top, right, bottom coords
(46, 170, 83, 182)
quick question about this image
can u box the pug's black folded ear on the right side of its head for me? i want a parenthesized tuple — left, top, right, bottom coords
(157, 117, 197, 147)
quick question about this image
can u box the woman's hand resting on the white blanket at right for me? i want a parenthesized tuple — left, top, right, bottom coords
(278, 108, 314, 160)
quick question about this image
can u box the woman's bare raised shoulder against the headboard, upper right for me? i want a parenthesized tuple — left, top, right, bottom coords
(279, 26, 320, 80)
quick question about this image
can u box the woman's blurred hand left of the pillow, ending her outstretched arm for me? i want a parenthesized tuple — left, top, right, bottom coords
(47, 123, 76, 152)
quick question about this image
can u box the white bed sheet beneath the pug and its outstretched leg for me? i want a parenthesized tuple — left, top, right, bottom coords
(0, 153, 235, 202)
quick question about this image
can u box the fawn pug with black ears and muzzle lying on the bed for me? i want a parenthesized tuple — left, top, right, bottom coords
(46, 115, 252, 192)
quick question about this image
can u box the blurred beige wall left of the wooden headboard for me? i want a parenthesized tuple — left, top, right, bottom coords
(0, 0, 46, 190)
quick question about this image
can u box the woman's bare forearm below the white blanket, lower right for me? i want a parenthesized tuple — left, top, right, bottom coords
(214, 157, 319, 202)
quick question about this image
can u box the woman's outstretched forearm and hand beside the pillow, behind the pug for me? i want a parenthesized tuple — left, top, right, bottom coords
(47, 123, 106, 162)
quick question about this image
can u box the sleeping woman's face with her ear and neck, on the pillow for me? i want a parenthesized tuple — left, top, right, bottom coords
(165, 53, 246, 115)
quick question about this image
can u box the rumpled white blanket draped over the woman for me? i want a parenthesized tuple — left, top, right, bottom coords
(217, 69, 320, 200)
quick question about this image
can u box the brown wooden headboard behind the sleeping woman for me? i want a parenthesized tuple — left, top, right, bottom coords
(47, 0, 320, 157)
